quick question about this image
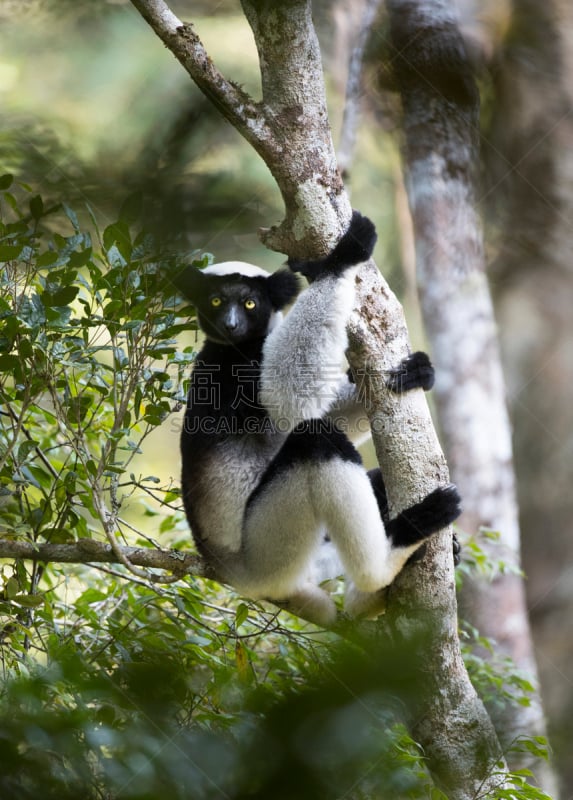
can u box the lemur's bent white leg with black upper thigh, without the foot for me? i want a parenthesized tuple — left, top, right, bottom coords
(243, 420, 389, 600)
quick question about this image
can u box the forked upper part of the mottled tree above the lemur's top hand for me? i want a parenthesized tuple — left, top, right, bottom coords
(132, 0, 351, 258)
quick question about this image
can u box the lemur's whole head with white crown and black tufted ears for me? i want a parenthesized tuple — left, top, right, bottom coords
(175, 261, 299, 345)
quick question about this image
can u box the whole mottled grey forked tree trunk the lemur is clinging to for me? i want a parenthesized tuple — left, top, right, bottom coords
(126, 0, 510, 800)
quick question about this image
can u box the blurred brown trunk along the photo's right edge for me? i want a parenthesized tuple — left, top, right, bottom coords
(484, 0, 573, 797)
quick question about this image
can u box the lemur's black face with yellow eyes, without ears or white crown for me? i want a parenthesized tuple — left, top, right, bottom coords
(195, 275, 273, 345)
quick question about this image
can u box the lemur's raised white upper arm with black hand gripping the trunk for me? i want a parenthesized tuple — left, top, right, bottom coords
(259, 212, 376, 431)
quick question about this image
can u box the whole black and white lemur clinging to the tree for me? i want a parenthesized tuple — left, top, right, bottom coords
(176, 212, 460, 624)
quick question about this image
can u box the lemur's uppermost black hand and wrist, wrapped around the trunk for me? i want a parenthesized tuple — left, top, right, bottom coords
(288, 211, 377, 283)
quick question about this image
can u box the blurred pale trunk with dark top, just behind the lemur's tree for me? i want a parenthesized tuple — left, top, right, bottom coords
(389, 0, 554, 791)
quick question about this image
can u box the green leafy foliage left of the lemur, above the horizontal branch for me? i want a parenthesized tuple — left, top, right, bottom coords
(0, 176, 192, 564)
